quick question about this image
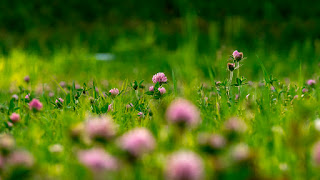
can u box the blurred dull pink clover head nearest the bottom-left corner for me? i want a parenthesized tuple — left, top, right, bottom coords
(8, 150, 34, 168)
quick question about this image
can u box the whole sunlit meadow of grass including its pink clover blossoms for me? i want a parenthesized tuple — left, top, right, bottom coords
(0, 32, 320, 179)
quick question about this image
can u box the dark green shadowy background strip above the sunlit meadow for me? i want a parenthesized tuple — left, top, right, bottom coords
(0, 0, 320, 54)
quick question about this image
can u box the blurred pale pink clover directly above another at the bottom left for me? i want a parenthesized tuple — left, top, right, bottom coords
(85, 116, 116, 140)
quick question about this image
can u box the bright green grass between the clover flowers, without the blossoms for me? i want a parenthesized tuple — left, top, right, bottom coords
(0, 35, 320, 179)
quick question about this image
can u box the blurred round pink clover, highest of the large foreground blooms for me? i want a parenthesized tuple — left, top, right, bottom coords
(166, 99, 201, 126)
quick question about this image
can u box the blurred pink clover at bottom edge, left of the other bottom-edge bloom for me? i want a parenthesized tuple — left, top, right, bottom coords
(78, 148, 118, 171)
